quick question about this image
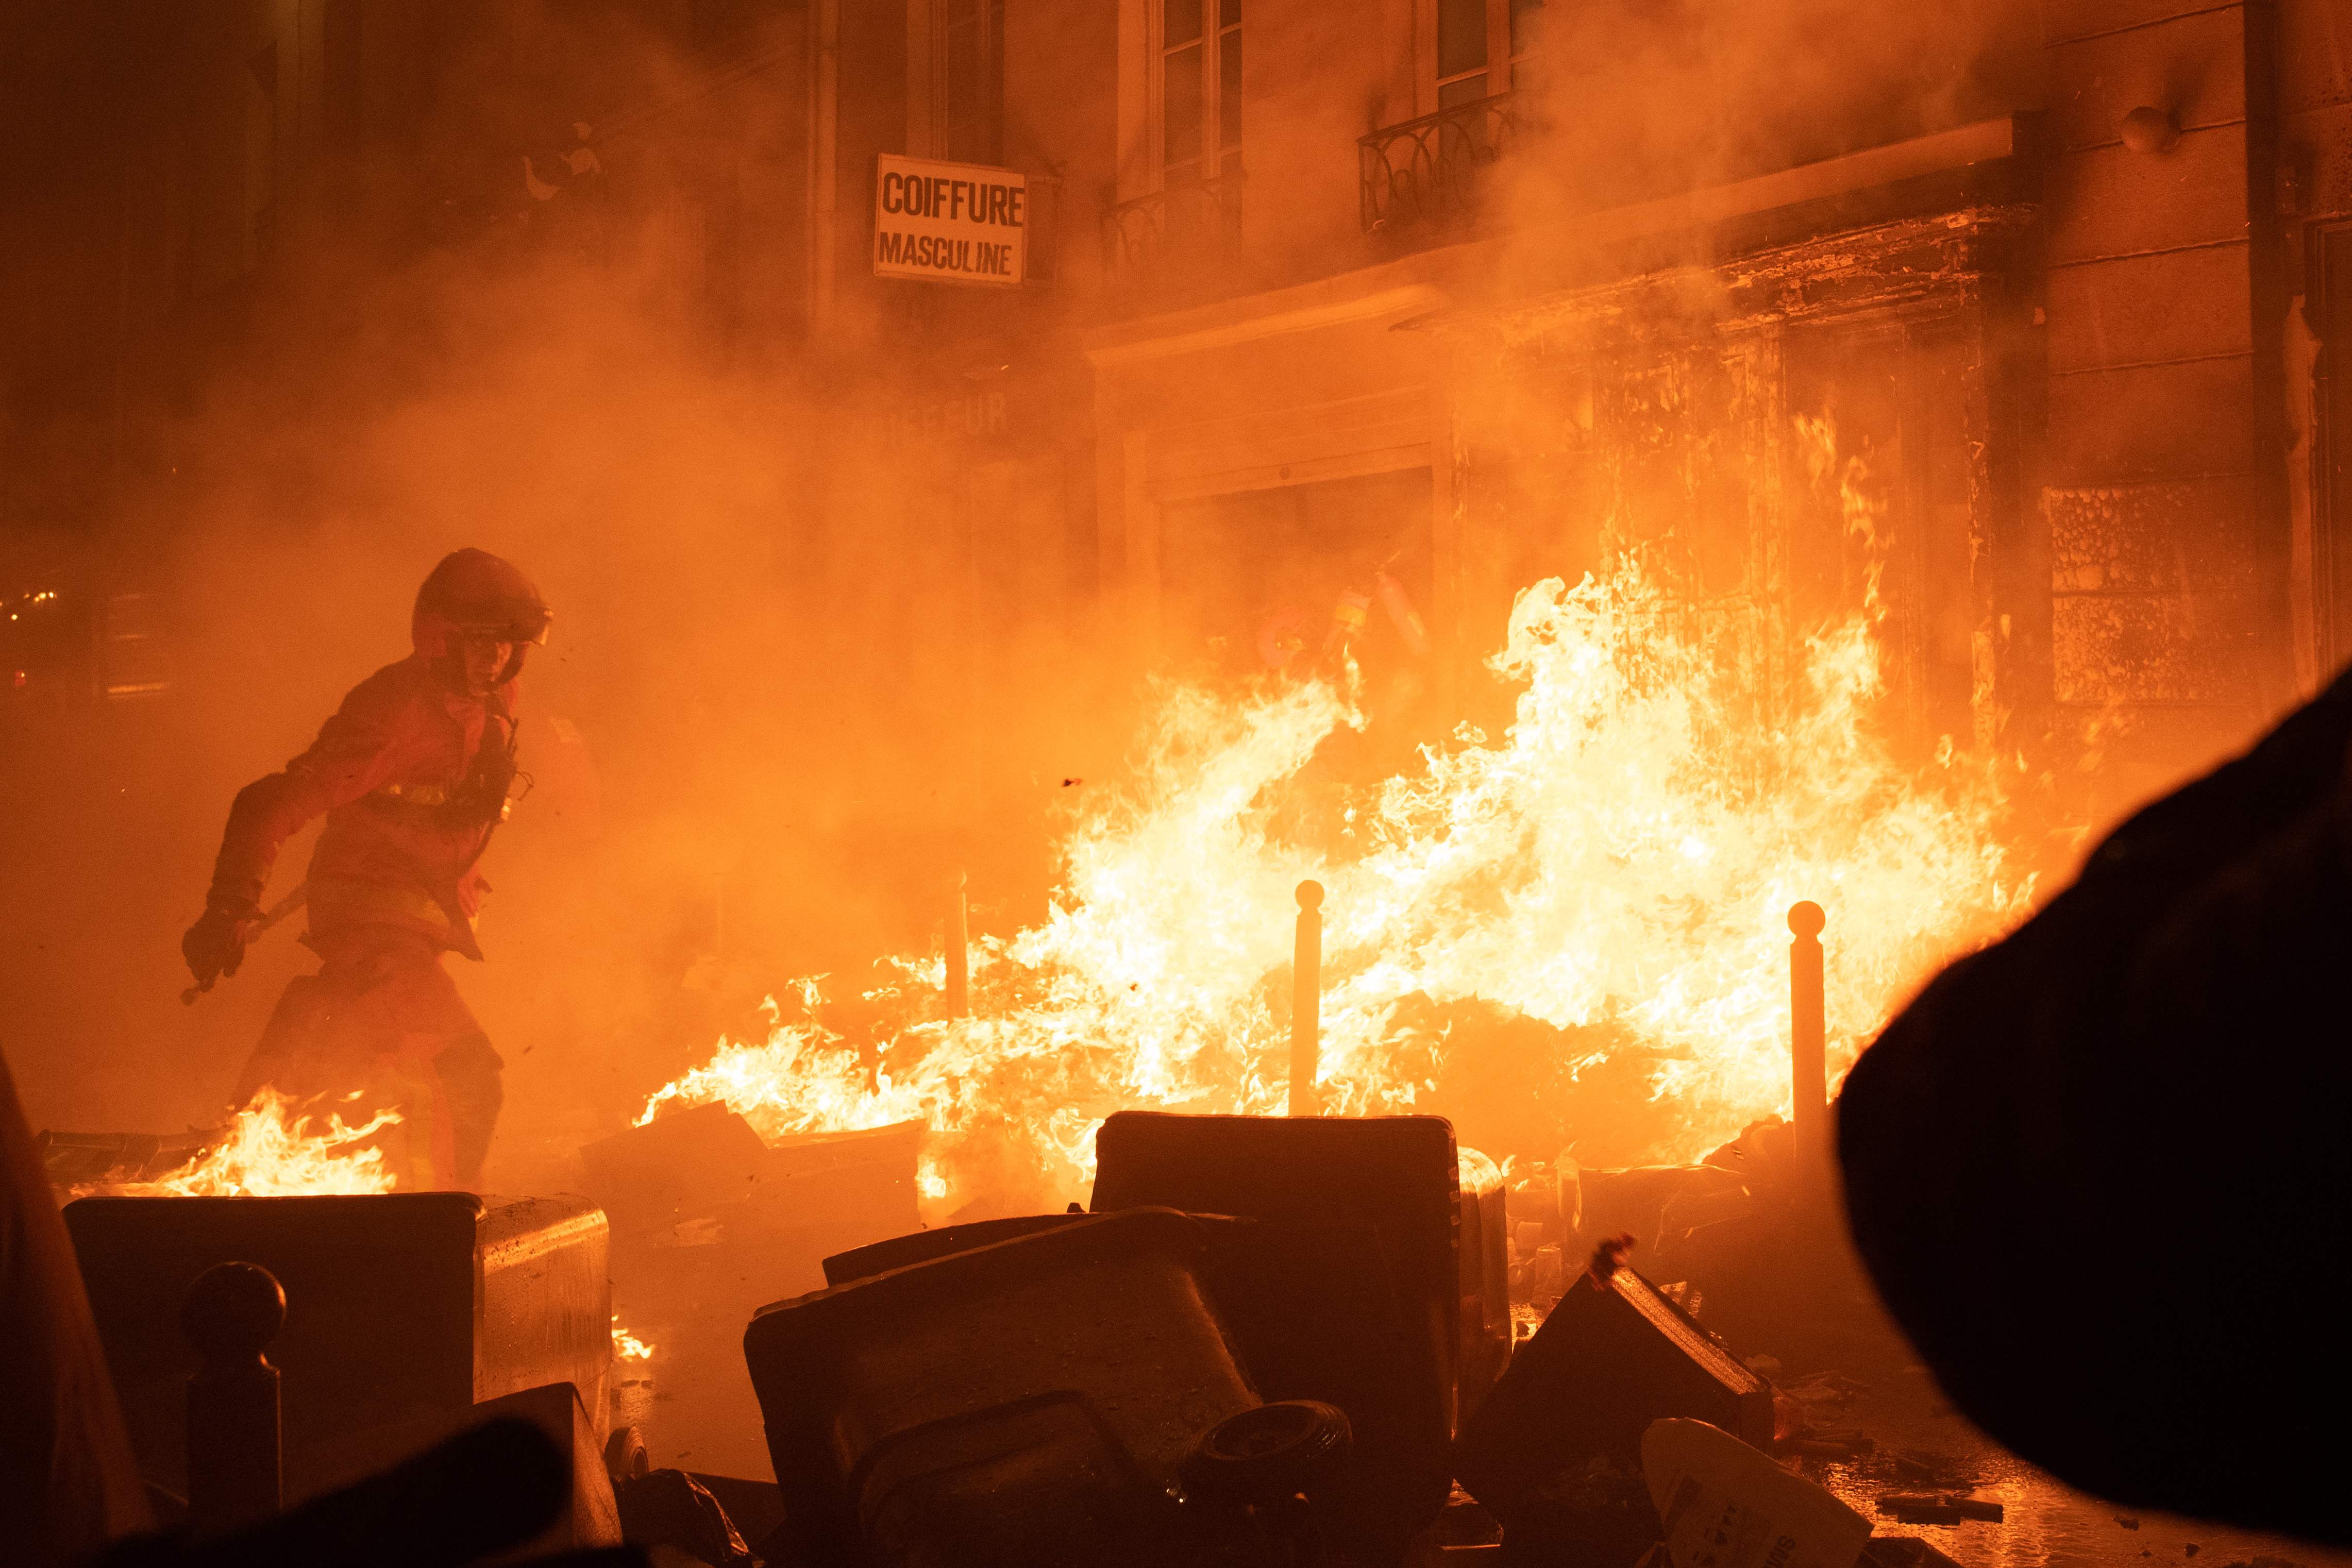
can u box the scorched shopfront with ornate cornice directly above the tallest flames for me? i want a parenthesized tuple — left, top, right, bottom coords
(1439, 212, 2048, 760)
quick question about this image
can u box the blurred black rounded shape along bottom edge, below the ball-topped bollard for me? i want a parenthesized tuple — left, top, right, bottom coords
(94, 1418, 597, 1568)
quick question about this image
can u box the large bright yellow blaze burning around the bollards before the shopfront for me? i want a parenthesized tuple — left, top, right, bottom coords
(640, 442, 2030, 1204)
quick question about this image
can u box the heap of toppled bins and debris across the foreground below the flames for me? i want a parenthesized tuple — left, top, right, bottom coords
(68, 1105, 1999, 1568)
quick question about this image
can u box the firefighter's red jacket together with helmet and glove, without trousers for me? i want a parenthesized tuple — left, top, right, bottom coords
(212, 550, 539, 959)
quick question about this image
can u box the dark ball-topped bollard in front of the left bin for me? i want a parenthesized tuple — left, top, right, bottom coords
(179, 1262, 287, 1535)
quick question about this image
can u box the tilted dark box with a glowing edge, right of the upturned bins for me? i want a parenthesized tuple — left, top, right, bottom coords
(1456, 1237, 1773, 1540)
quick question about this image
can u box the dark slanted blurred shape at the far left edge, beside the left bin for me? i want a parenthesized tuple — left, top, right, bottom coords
(0, 1058, 153, 1568)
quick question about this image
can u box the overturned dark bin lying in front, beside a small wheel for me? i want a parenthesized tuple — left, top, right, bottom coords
(743, 1208, 1258, 1568)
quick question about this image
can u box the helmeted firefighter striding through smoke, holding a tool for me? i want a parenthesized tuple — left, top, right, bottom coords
(181, 550, 550, 1189)
